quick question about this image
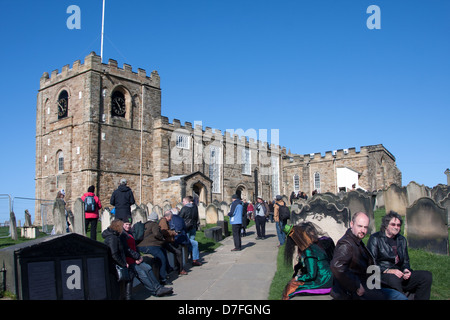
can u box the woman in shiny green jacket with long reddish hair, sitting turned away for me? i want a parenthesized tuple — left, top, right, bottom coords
(283, 222, 334, 300)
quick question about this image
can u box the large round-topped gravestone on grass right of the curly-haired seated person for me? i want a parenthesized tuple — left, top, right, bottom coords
(405, 197, 448, 255)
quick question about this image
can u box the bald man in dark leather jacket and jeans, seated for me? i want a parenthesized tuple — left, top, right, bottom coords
(330, 212, 407, 300)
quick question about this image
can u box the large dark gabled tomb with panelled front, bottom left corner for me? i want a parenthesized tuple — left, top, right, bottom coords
(0, 233, 115, 300)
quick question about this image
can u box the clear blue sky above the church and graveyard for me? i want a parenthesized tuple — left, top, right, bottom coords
(0, 0, 450, 218)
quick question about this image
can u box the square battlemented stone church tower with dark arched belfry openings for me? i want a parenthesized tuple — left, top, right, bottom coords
(36, 52, 161, 220)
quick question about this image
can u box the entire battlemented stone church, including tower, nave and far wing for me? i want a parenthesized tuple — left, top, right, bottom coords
(35, 52, 401, 221)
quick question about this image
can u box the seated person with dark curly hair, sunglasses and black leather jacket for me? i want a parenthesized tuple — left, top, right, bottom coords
(367, 211, 432, 300)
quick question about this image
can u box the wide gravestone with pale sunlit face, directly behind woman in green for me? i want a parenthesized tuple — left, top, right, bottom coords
(291, 197, 351, 243)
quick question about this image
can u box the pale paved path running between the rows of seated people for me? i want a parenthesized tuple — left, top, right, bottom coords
(133, 222, 278, 300)
